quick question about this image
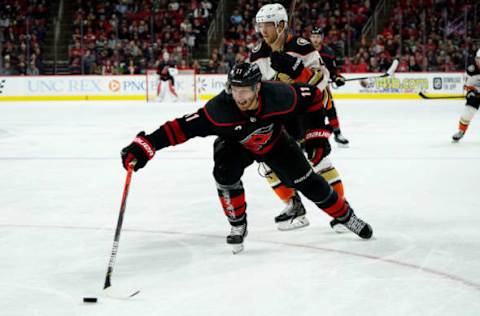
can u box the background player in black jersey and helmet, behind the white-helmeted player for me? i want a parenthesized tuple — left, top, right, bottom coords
(310, 27, 349, 146)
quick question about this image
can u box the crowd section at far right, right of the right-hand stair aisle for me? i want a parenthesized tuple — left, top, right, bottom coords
(343, 0, 480, 72)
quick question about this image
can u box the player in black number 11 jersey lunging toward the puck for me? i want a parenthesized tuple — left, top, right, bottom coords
(121, 63, 372, 253)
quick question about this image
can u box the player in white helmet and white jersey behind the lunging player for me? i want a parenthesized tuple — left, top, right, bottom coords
(249, 3, 343, 231)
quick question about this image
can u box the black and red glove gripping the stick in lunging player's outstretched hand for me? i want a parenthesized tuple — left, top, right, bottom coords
(120, 132, 155, 171)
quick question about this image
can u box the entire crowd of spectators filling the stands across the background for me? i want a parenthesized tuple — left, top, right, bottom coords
(0, 0, 480, 75)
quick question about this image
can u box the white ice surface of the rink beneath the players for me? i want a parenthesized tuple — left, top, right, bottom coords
(0, 100, 480, 316)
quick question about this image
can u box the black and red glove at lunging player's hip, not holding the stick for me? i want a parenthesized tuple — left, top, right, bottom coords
(305, 128, 332, 167)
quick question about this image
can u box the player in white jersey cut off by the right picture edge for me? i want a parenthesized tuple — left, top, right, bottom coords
(452, 49, 480, 143)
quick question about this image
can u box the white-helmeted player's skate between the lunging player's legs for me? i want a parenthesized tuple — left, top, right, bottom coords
(275, 194, 310, 231)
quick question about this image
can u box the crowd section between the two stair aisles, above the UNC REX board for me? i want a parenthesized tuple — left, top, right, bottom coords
(69, 0, 215, 74)
